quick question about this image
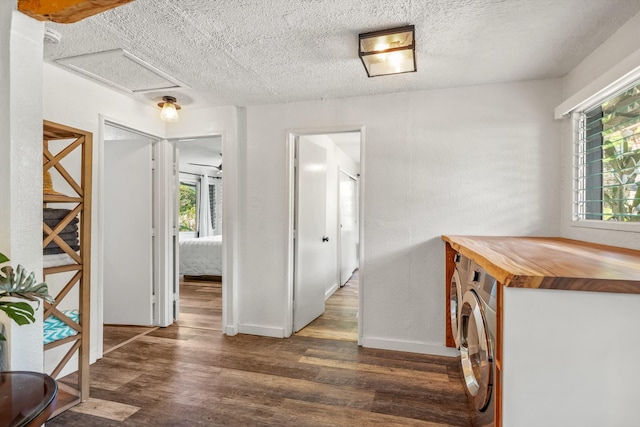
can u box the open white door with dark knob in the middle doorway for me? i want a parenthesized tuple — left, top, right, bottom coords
(293, 139, 328, 332)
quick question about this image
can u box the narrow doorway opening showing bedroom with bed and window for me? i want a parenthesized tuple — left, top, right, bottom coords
(172, 135, 224, 332)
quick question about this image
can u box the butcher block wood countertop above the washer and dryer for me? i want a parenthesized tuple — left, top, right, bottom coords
(442, 235, 640, 294)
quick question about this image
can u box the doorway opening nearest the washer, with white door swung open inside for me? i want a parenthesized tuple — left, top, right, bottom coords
(290, 129, 362, 341)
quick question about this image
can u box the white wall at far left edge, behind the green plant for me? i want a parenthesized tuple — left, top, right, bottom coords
(0, 8, 44, 371)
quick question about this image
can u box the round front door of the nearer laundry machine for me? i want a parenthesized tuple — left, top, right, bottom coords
(460, 290, 493, 411)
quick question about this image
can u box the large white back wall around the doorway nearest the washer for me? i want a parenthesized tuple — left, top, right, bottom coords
(239, 80, 560, 354)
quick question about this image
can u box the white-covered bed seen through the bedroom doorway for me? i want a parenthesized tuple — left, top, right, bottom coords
(180, 236, 222, 280)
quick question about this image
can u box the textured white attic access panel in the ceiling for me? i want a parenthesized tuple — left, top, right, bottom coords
(56, 49, 190, 93)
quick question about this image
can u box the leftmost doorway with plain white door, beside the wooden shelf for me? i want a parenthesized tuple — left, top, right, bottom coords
(97, 119, 177, 355)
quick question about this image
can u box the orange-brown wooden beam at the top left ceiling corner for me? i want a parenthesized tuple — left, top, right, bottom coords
(17, 0, 134, 24)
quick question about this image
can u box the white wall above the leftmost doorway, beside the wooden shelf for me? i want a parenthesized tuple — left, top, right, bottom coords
(39, 63, 165, 369)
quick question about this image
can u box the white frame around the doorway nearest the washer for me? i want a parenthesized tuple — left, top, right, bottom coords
(284, 126, 365, 345)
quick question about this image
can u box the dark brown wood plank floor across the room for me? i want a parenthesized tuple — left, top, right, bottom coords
(47, 275, 470, 427)
